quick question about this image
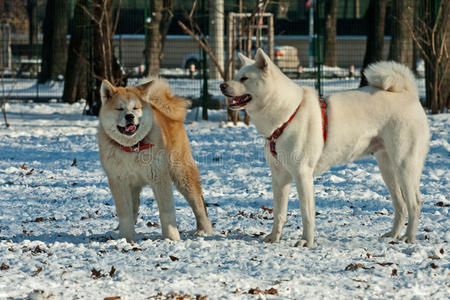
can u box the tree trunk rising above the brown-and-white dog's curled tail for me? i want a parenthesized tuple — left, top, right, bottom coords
(144, 0, 173, 76)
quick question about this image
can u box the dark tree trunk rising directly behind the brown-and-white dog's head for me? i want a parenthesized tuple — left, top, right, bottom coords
(87, 0, 126, 116)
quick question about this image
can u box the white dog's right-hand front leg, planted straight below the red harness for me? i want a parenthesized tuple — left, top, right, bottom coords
(295, 168, 316, 248)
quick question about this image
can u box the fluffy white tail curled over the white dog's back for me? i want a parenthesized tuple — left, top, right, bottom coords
(364, 61, 418, 96)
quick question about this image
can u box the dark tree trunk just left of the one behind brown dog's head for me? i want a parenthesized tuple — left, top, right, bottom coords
(62, 0, 90, 103)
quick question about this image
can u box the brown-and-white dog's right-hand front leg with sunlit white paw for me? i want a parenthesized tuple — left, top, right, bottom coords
(151, 176, 180, 241)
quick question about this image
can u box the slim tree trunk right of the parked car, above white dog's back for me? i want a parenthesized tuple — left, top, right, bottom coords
(324, 0, 338, 67)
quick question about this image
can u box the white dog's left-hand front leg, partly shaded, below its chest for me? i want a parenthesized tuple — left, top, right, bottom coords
(264, 162, 292, 243)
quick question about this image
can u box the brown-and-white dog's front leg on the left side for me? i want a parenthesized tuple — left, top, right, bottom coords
(109, 179, 135, 242)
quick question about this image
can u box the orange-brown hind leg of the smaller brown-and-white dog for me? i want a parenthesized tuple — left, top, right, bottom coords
(171, 156, 212, 235)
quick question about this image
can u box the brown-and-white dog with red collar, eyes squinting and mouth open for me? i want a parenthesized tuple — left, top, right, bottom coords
(98, 79, 212, 242)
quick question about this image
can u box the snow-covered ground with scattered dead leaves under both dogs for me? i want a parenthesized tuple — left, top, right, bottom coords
(0, 98, 450, 299)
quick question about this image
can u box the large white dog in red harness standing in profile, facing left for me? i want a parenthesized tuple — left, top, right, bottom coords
(220, 49, 430, 247)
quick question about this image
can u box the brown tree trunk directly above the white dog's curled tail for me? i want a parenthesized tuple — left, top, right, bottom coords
(389, 0, 414, 69)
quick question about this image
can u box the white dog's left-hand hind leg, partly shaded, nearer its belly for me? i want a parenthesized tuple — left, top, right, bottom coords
(375, 150, 406, 239)
